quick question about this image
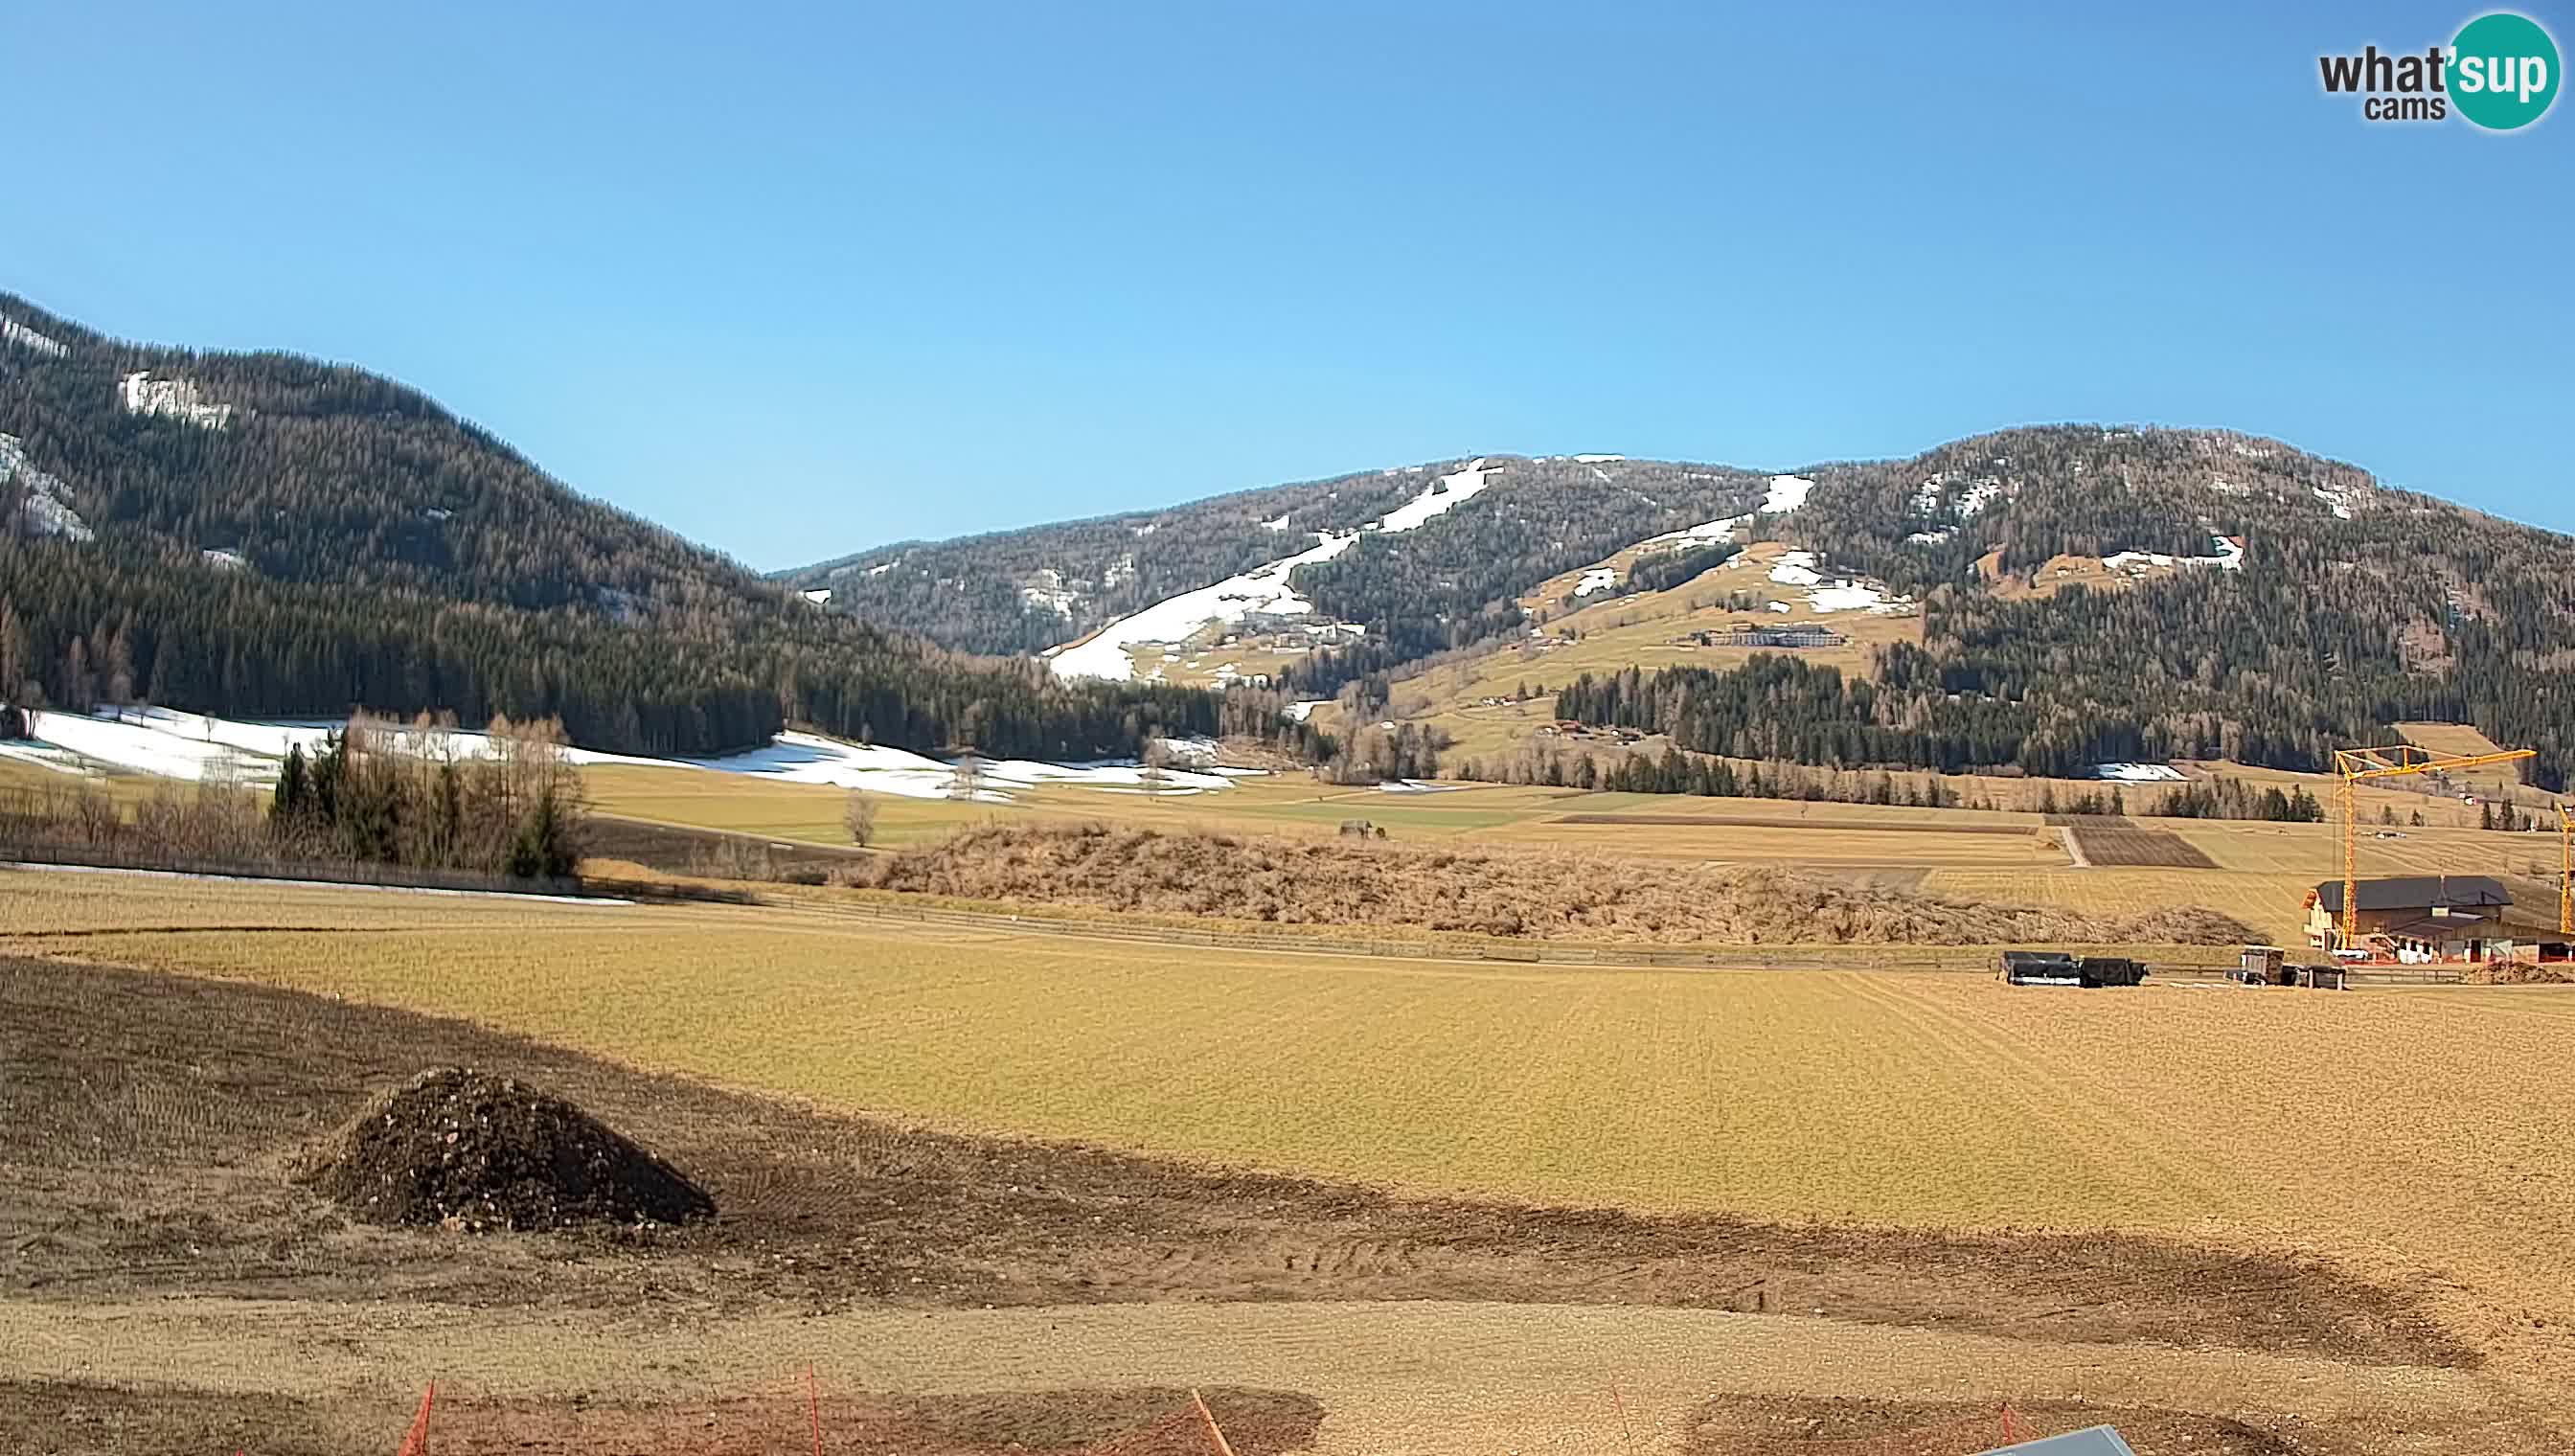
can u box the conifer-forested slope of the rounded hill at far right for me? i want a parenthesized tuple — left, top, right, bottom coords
(1565, 425, 2575, 788)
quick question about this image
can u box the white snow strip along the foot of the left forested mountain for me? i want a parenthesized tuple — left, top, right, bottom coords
(0, 709, 1246, 804)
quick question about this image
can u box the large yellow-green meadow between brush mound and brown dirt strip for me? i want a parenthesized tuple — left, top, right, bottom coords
(14, 871, 2575, 1350)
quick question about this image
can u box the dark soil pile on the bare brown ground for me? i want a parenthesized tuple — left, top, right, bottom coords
(304, 1067, 716, 1235)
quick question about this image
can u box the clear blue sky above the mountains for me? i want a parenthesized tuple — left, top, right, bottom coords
(0, 0, 2575, 567)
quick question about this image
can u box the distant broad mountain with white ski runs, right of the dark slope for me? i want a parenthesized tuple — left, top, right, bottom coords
(786, 425, 2575, 786)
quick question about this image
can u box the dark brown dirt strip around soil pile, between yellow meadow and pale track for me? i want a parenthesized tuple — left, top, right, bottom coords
(0, 961, 2474, 1366)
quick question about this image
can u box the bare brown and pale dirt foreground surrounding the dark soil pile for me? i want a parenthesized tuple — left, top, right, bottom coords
(0, 961, 2552, 1456)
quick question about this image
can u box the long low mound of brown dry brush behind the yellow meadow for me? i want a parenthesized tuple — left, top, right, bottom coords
(847, 825, 2245, 945)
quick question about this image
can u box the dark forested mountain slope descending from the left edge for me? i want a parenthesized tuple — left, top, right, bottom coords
(0, 294, 1218, 758)
